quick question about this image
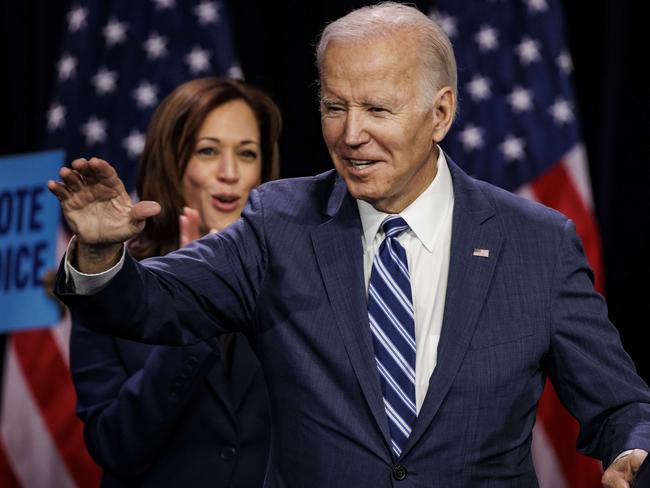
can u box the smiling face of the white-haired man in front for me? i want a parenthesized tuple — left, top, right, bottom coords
(321, 35, 446, 213)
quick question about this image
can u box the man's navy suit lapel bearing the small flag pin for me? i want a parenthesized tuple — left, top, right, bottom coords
(402, 161, 502, 456)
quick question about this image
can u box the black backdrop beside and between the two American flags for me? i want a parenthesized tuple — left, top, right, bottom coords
(0, 0, 650, 382)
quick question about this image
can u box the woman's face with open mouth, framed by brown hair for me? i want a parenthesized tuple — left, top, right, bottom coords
(183, 100, 262, 231)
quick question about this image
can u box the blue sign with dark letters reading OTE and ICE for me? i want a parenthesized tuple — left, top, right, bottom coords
(0, 151, 64, 331)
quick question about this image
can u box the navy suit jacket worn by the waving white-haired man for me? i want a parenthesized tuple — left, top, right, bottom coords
(57, 162, 650, 488)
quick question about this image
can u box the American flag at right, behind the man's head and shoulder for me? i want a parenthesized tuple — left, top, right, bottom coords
(430, 0, 603, 488)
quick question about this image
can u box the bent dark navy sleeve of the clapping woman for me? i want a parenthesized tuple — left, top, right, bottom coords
(70, 324, 218, 477)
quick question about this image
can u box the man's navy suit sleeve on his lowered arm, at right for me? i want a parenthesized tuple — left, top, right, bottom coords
(547, 221, 650, 466)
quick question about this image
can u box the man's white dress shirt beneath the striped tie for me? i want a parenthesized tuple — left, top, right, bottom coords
(357, 150, 454, 413)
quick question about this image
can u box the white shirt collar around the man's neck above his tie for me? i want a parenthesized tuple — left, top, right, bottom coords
(357, 147, 454, 252)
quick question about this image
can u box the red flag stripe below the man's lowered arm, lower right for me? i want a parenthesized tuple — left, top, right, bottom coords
(537, 381, 603, 488)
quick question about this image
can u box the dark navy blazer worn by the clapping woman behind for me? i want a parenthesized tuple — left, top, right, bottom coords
(70, 323, 270, 488)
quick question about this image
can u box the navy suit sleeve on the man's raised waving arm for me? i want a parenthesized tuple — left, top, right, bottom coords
(55, 186, 267, 345)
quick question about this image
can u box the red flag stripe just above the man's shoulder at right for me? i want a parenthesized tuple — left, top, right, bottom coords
(530, 163, 605, 293)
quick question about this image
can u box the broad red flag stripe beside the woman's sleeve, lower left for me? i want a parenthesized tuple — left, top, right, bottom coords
(11, 329, 100, 487)
